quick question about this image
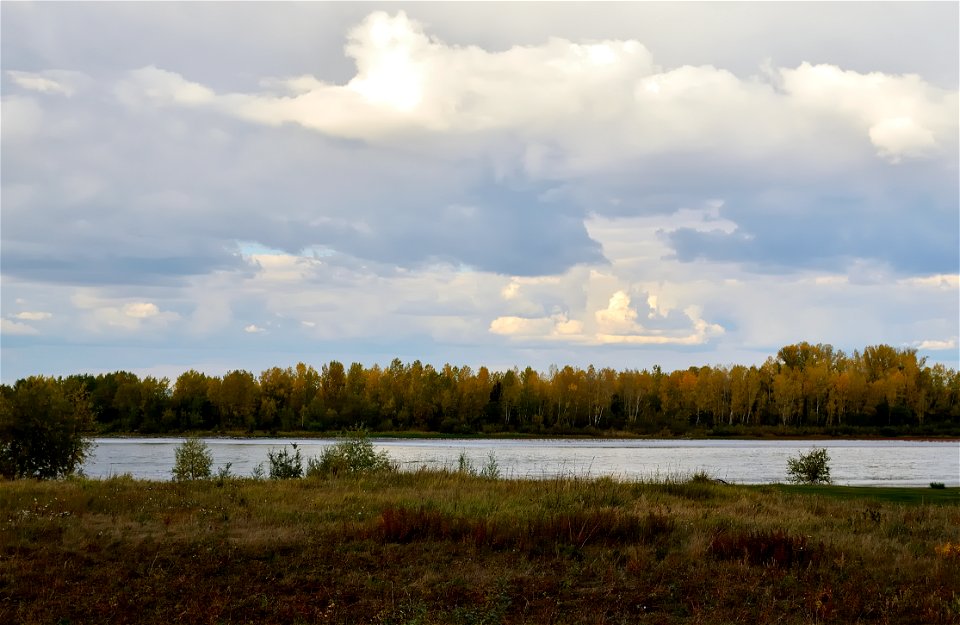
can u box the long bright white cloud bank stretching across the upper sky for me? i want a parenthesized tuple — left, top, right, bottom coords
(123, 11, 958, 171)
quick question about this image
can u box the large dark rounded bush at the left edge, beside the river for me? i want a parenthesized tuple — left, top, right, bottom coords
(0, 376, 93, 479)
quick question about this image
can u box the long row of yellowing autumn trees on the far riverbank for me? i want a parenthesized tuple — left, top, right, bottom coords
(0, 342, 960, 436)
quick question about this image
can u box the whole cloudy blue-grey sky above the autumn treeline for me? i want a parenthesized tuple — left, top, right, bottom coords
(0, 2, 960, 383)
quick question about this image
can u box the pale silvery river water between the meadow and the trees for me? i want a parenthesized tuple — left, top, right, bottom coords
(83, 438, 960, 486)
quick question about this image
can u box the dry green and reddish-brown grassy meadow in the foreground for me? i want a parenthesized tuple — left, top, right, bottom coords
(0, 471, 960, 624)
